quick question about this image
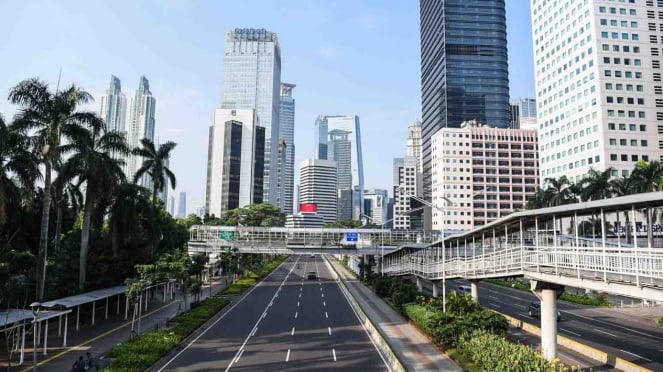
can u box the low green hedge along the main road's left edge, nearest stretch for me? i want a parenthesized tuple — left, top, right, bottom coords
(105, 297, 230, 371)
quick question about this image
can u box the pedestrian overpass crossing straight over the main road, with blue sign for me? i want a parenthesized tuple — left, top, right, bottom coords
(188, 225, 441, 260)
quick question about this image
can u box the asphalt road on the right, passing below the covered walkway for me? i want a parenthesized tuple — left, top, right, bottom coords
(454, 280, 663, 371)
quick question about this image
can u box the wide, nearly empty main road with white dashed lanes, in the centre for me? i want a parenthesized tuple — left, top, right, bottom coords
(161, 256, 388, 371)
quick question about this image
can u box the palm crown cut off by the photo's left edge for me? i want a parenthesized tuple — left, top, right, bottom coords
(0, 115, 40, 226)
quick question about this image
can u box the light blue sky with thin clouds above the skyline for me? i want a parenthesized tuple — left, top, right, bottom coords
(0, 0, 534, 212)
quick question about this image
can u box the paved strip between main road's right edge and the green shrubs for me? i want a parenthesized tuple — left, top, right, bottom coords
(329, 258, 461, 371)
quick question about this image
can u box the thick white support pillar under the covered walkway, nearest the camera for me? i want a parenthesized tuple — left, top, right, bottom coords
(530, 280, 564, 360)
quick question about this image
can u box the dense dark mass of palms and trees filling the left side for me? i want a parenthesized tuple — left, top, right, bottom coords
(0, 78, 183, 307)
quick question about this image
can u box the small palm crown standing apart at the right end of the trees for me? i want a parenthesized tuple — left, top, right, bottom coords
(132, 138, 177, 205)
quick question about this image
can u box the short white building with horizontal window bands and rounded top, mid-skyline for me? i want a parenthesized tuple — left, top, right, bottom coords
(299, 159, 338, 223)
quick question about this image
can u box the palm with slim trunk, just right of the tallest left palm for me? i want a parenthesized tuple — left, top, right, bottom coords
(62, 122, 129, 291)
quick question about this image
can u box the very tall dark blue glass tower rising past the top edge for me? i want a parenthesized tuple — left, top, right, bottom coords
(419, 0, 509, 200)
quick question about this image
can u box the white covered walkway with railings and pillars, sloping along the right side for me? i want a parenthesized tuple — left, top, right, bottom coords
(383, 192, 663, 359)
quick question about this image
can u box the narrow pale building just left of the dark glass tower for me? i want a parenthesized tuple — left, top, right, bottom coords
(393, 156, 423, 230)
